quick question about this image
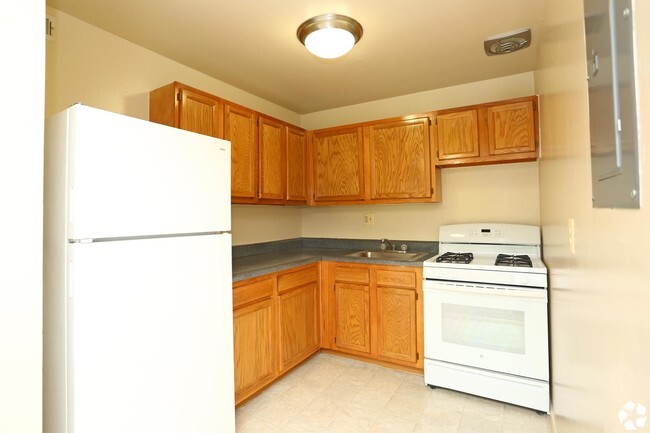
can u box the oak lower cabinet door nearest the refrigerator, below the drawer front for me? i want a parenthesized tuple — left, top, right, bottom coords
(233, 299, 275, 403)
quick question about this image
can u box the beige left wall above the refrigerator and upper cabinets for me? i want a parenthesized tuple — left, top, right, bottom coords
(46, 8, 300, 125)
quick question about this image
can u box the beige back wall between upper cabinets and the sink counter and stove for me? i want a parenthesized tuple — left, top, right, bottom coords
(302, 162, 539, 240)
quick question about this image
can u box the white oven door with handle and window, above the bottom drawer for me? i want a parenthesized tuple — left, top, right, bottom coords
(424, 280, 549, 380)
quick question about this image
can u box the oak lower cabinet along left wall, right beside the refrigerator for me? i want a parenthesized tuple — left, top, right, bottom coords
(233, 263, 320, 405)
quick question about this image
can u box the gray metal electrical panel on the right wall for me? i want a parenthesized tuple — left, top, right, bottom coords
(584, 0, 640, 208)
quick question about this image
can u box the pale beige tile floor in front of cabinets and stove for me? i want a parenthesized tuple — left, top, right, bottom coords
(237, 354, 550, 433)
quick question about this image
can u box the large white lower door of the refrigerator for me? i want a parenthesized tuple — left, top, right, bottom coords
(67, 234, 235, 433)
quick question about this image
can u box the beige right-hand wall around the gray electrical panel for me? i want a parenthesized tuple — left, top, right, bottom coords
(535, 0, 650, 433)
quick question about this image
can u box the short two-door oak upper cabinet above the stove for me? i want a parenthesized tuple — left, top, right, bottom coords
(434, 96, 539, 167)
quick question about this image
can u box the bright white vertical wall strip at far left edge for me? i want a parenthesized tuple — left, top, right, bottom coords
(0, 0, 45, 433)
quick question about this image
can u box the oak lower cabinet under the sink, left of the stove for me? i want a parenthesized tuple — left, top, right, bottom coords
(321, 262, 424, 369)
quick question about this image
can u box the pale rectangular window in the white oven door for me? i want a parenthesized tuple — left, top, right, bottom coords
(441, 303, 526, 355)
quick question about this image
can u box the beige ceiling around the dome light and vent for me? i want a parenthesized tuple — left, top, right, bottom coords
(47, 0, 544, 114)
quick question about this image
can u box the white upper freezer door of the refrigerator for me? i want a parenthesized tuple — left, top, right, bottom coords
(62, 105, 230, 239)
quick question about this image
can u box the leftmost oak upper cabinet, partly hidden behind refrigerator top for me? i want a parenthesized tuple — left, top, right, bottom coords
(149, 82, 223, 138)
